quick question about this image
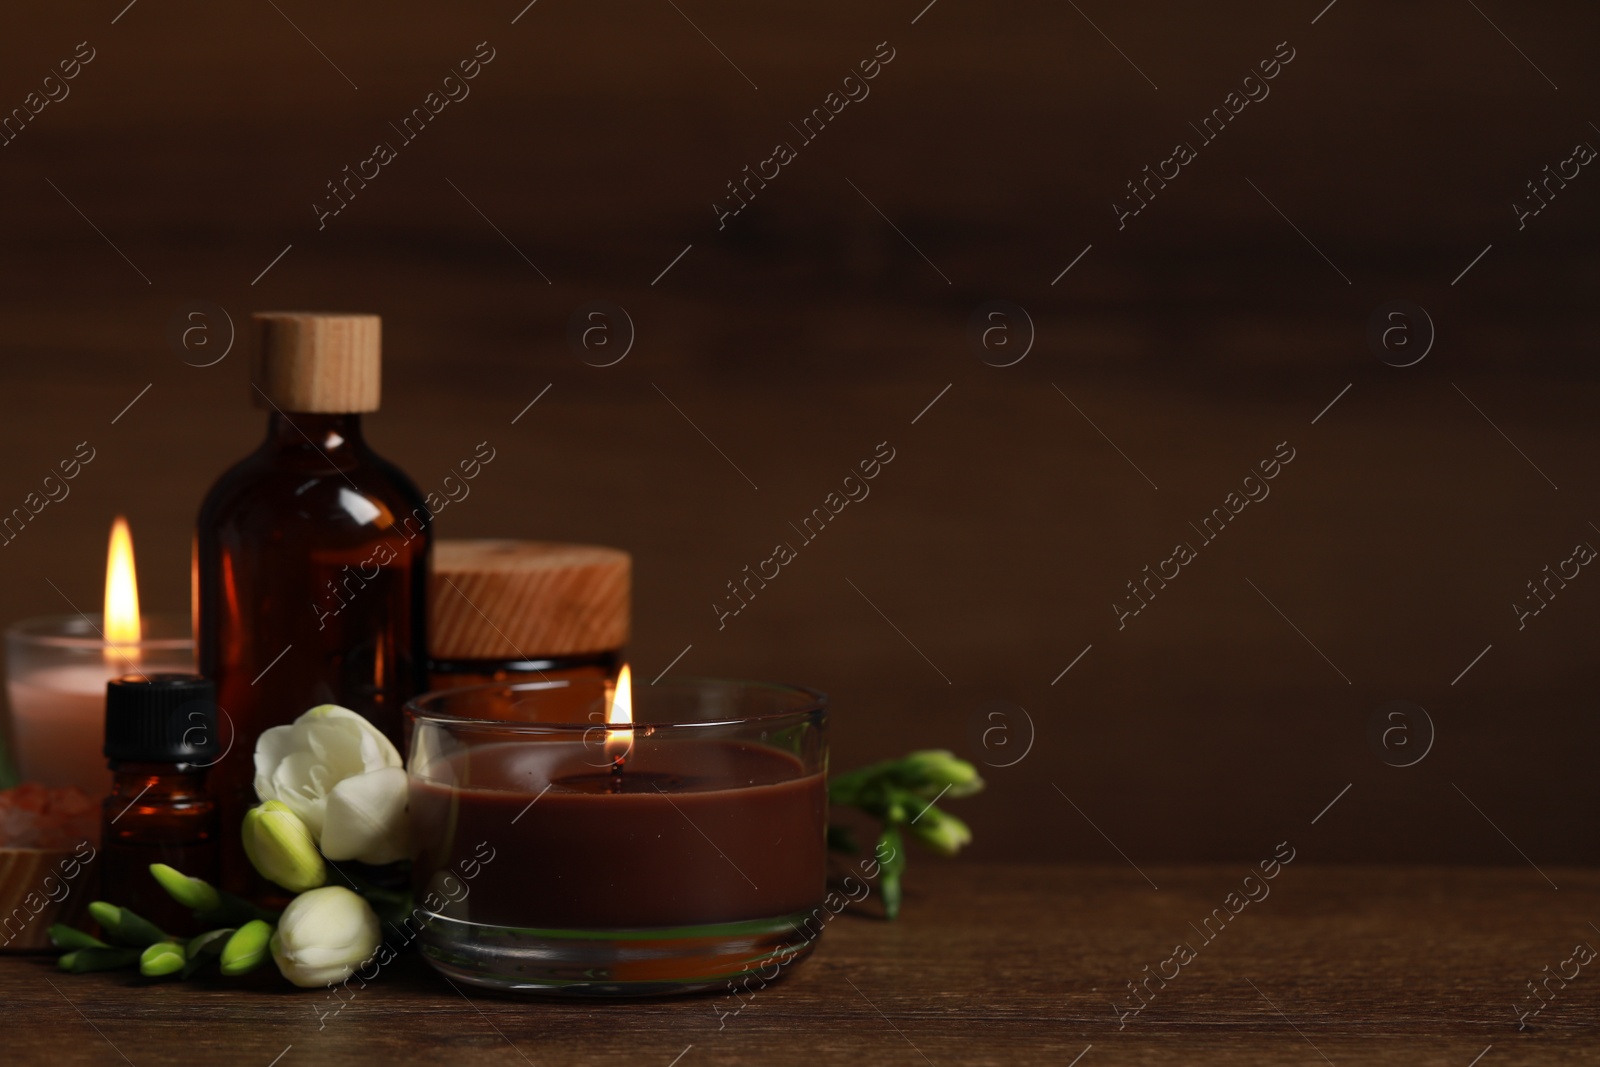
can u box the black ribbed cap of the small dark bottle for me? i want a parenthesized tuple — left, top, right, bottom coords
(104, 673, 221, 765)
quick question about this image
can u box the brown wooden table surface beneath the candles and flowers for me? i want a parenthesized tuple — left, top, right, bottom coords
(0, 857, 1600, 1067)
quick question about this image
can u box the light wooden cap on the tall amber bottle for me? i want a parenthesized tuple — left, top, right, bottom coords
(251, 312, 382, 414)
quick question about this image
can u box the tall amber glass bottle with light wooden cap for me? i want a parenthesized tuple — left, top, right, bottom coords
(195, 312, 432, 891)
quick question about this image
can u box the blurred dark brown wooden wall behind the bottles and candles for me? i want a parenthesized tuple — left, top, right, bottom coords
(0, 0, 1600, 878)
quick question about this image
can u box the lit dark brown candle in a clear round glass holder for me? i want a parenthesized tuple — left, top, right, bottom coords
(408, 669, 827, 997)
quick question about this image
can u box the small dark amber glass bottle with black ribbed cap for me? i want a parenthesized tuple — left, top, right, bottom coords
(99, 673, 222, 936)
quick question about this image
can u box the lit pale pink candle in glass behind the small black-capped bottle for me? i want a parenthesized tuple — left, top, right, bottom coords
(6, 515, 194, 797)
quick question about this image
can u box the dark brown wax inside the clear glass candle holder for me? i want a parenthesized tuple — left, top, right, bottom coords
(411, 739, 827, 929)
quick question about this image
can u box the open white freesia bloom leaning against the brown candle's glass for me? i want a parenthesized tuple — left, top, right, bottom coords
(256, 704, 408, 864)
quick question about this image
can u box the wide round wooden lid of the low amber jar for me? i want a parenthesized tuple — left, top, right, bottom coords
(427, 541, 634, 661)
